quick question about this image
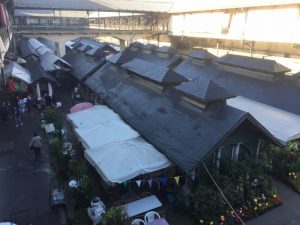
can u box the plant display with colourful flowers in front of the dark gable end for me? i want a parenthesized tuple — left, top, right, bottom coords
(192, 161, 281, 224)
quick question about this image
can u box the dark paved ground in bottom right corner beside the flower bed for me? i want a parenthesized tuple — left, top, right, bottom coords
(246, 180, 300, 225)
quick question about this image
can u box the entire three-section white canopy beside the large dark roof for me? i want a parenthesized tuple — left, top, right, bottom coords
(68, 105, 170, 183)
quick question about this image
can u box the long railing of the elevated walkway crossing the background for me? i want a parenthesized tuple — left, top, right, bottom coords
(13, 24, 166, 33)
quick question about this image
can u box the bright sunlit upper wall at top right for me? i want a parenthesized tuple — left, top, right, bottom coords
(168, 5, 300, 44)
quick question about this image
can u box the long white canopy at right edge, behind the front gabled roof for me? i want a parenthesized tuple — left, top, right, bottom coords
(227, 96, 300, 143)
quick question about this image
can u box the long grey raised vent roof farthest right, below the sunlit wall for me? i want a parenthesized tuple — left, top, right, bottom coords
(215, 54, 291, 74)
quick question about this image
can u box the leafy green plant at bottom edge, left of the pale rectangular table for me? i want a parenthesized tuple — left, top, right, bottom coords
(103, 207, 131, 225)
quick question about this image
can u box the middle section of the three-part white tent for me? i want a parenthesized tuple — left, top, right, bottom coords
(75, 120, 139, 149)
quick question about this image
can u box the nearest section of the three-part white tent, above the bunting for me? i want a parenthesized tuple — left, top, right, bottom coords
(85, 137, 170, 183)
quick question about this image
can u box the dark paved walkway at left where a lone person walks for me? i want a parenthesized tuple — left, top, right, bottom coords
(0, 108, 65, 225)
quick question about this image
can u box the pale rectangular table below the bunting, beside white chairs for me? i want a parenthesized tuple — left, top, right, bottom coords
(123, 195, 162, 217)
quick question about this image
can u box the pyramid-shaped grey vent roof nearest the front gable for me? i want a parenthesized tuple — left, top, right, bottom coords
(175, 77, 236, 102)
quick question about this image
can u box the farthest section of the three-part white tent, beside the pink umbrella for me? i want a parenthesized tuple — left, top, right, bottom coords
(68, 105, 122, 128)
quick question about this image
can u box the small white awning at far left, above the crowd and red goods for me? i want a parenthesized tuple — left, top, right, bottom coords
(4, 62, 32, 84)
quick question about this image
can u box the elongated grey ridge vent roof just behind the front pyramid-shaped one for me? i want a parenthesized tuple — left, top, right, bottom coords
(122, 58, 187, 84)
